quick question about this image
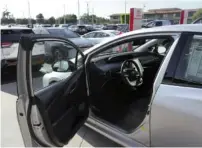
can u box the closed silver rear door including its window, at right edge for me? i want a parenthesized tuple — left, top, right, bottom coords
(150, 32, 202, 147)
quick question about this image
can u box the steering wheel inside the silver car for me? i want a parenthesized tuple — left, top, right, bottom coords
(121, 60, 143, 87)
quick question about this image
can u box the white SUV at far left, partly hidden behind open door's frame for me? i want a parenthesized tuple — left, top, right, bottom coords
(0, 26, 44, 72)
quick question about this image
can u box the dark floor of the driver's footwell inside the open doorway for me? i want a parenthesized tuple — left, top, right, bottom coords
(92, 98, 148, 132)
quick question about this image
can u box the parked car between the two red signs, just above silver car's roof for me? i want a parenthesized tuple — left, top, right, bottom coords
(142, 20, 172, 28)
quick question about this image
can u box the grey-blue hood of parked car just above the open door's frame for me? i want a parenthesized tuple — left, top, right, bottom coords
(69, 38, 95, 48)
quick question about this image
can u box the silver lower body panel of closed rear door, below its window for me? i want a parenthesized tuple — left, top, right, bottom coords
(151, 84, 202, 147)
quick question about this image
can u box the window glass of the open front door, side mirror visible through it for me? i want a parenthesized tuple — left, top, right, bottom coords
(32, 41, 83, 91)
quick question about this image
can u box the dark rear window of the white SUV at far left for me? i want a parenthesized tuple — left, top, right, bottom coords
(1, 29, 33, 42)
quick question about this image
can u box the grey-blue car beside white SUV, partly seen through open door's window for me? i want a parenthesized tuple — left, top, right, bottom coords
(33, 27, 95, 63)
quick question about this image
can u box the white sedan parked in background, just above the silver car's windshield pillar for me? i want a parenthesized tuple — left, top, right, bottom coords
(82, 30, 122, 43)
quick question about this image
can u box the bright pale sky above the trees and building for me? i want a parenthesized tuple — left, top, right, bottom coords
(0, 0, 202, 18)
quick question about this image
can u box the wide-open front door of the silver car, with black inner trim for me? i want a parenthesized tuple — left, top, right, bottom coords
(16, 35, 89, 147)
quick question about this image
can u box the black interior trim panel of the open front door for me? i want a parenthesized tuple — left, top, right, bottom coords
(35, 71, 88, 139)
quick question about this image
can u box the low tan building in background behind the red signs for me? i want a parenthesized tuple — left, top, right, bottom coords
(110, 8, 199, 24)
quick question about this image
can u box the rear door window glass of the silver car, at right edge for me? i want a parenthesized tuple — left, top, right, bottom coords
(176, 35, 202, 84)
